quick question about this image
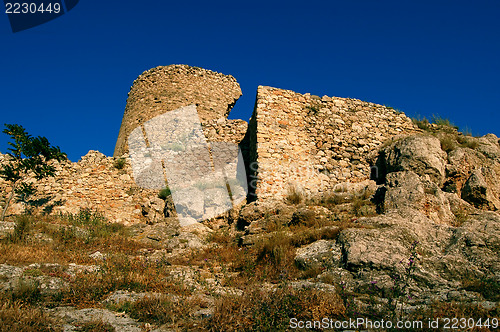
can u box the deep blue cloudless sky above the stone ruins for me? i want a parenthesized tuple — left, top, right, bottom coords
(0, 0, 500, 161)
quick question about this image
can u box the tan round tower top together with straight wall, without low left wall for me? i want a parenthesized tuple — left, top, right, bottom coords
(114, 65, 419, 200)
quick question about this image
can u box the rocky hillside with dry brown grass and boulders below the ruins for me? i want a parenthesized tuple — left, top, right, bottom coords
(0, 127, 500, 331)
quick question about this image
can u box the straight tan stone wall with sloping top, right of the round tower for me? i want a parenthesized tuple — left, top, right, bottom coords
(248, 86, 419, 199)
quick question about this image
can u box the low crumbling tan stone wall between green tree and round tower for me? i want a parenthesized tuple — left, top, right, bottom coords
(0, 151, 156, 224)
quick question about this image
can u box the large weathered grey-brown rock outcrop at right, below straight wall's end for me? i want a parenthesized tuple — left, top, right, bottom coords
(272, 135, 500, 313)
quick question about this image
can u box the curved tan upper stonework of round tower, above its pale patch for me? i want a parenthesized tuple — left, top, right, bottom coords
(113, 65, 246, 157)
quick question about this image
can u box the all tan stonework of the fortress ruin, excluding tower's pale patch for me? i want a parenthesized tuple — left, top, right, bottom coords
(0, 65, 420, 224)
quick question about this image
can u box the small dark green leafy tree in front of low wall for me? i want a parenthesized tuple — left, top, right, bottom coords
(0, 124, 66, 220)
